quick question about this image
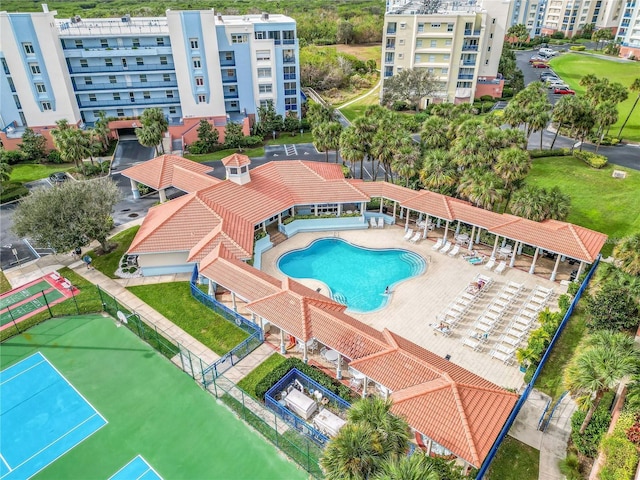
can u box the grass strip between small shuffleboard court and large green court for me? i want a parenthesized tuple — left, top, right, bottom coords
(0, 268, 102, 341)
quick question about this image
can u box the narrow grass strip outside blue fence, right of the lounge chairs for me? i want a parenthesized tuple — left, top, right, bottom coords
(535, 307, 587, 403)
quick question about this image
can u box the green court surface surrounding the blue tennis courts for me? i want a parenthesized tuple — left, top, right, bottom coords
(0, 315, 308, 480)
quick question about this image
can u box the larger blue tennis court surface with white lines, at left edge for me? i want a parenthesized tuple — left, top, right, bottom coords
(0, 352, 107, 480)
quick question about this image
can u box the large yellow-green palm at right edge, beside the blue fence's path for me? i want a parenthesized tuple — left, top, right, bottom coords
(564, 331, 640, 434)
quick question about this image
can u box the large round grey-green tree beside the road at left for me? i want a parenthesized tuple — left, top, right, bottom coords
(13, 177, 121, 252)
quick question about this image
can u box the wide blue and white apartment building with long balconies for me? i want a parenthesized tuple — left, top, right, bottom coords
(0, 5, 301, 148)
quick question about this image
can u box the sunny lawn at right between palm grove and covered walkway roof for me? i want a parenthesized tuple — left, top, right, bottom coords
(525, 156, 640, 257)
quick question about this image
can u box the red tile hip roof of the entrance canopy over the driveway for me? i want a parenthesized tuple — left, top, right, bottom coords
(120, 154, 220, 193)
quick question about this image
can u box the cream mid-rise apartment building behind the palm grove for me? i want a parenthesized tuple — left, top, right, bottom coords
(382, 0, 513, 106)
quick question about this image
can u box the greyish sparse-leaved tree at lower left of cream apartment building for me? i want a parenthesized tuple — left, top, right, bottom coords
(382, 68, 442, 111)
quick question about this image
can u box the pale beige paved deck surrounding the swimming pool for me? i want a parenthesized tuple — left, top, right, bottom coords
(262, 225, 574, 389)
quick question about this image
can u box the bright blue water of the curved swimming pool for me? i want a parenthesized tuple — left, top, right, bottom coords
(278, 238, 426, 313)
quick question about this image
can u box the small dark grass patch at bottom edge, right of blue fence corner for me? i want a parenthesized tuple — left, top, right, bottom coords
(486, 435, 540, 480)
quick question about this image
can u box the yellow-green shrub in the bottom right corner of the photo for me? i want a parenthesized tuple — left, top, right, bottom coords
(600, 412, 640, 480)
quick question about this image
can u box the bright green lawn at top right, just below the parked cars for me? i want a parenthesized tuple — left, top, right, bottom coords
(550, 53, 640, 141)
